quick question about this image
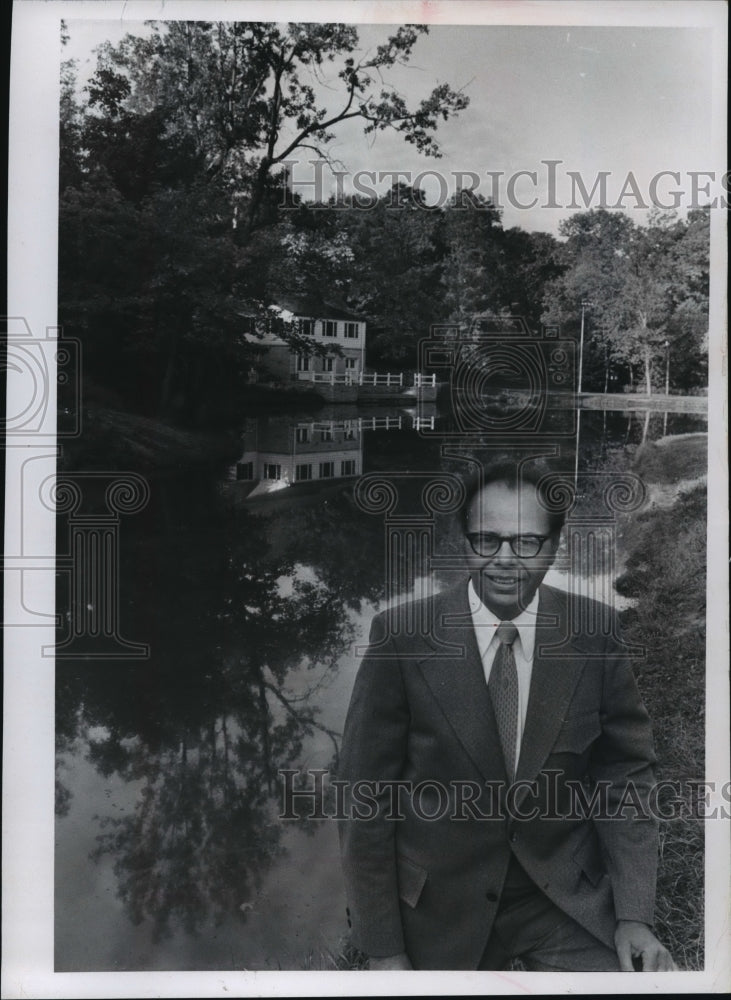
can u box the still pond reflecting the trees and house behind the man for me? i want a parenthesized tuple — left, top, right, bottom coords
(55, 398, 706, 971)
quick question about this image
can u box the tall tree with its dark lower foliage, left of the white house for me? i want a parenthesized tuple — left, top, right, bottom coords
(55, 22, 467, 420)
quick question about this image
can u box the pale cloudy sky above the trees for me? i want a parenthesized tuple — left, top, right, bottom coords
(64, 15, 721, 234)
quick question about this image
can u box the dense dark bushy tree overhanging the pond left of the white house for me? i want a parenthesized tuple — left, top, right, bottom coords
(59, 171, 266, 419)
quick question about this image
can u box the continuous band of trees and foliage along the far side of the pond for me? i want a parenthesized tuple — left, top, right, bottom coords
(59, 21, 709, 418)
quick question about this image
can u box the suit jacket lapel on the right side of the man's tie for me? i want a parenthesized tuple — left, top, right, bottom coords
(516, 586, 586, 781)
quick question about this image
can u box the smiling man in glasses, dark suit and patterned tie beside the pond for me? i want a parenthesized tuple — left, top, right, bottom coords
(339, 464, 674, 971)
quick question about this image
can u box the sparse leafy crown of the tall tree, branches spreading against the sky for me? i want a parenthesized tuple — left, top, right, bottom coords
(84, 22, 468, 231)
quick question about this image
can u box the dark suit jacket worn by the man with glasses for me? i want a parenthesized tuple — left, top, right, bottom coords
(339, 580, 657, 969)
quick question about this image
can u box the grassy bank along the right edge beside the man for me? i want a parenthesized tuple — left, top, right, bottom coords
(617, 483, 706, 969)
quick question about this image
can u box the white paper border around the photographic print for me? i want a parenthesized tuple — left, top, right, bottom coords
(2, 0, 731, 997)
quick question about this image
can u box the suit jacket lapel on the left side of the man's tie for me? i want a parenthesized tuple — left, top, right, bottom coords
(418, 581, 506, 781)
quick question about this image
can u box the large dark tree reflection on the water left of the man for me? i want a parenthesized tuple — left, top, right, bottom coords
(57, 484, 354, 940)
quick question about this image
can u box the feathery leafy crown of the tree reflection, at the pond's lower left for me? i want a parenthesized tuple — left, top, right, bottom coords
(88, 715, 281, 940)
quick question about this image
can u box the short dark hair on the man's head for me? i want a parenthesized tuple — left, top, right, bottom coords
(459, 459, 573, 535)
